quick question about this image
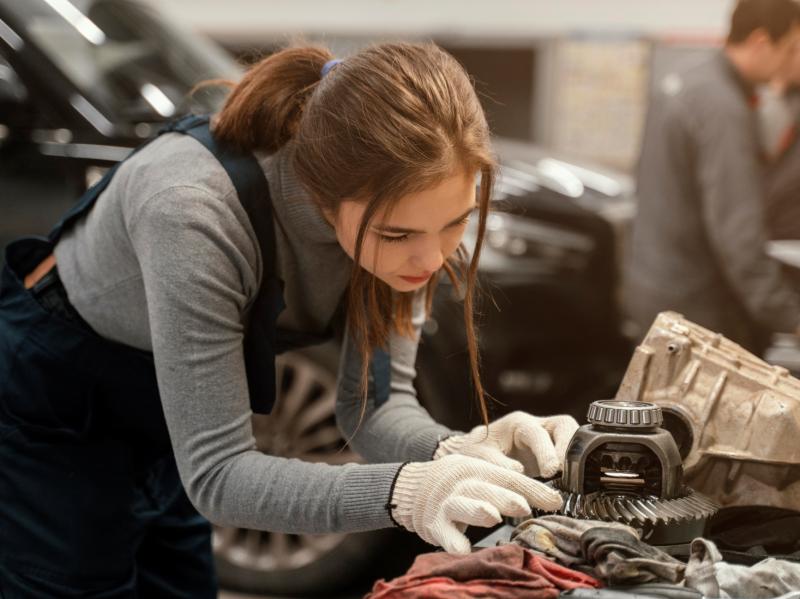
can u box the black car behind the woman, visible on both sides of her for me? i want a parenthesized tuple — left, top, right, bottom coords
(0, 0, 633, 596)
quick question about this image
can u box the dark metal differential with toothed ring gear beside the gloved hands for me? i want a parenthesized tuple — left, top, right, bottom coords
(549, 400, 718, 545)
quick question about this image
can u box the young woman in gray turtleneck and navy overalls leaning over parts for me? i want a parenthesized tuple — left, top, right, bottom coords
(0, 44, 577, 598)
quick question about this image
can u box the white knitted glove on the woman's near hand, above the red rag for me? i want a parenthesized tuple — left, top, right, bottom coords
(389, 455, 562, 553)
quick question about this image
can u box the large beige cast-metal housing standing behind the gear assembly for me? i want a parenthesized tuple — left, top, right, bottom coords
(616, 312, 800, 510)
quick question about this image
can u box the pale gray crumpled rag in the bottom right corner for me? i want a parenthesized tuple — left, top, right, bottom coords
(685, 539, 800, 599)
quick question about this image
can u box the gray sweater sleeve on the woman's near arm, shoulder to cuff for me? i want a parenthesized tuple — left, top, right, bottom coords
(129, 186, 400, 533)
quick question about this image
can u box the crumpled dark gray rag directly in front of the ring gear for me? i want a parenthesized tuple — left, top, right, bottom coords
(511, 515, 685, 584)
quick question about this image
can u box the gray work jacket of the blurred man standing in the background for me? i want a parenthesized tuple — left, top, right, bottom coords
(626, 52, 800, 352)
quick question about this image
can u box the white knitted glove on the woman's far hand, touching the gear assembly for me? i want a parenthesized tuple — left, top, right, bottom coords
(433, 411, 578, 478)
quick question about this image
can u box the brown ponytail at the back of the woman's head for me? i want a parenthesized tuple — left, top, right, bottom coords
(214, 47, 333, 153)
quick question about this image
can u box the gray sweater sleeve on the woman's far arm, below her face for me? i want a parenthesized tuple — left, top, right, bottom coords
(336, 292, 454, 463)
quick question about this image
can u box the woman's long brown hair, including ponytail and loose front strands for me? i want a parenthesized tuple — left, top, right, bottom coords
(215, 43, 495, 422)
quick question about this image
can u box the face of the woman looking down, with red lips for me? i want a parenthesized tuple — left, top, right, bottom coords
(334, 172, 475, 291)
